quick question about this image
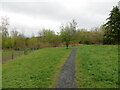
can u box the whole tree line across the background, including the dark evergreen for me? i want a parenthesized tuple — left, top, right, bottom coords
(0, 6, 120, 50)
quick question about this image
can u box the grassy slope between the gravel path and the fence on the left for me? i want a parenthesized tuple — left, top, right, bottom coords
(3, 48, 71, 88)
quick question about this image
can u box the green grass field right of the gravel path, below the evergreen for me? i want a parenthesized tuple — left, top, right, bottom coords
(76, 45, 118, 88)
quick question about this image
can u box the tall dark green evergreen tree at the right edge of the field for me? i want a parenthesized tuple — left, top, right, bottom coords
(104, 6, 120, 44)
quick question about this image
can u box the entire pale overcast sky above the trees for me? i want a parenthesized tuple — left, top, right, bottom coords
(0, 0, 119, 36)
